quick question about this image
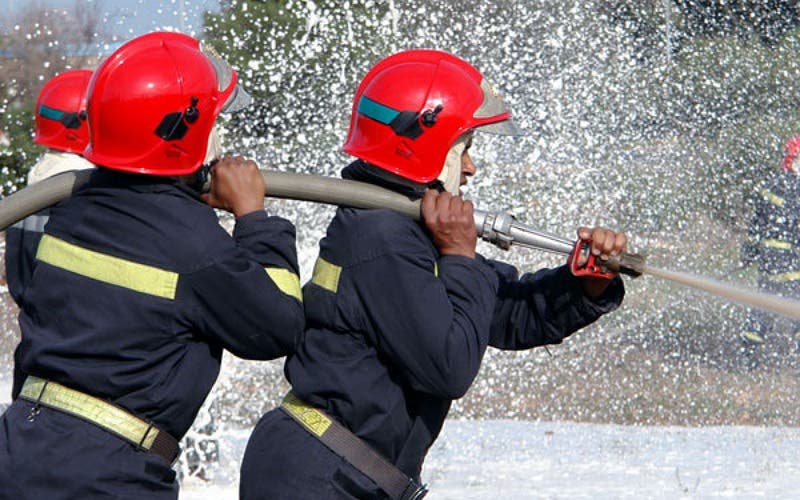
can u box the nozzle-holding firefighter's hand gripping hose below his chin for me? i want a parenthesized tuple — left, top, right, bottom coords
(422, 189, 478, 258)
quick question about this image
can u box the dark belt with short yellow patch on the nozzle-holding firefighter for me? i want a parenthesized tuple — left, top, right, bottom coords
(281, 392, 428, 500)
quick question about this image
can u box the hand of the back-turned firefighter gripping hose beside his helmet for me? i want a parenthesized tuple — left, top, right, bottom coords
(201, 156, 266, 217)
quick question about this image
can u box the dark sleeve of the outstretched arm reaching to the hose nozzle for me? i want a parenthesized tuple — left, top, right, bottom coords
(487, 261, 625, 350)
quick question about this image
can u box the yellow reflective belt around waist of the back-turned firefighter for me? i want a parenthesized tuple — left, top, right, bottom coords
(19, 377, 181, 465)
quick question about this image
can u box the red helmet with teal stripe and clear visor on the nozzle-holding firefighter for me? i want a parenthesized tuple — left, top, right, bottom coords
(344, 50, 520, 183)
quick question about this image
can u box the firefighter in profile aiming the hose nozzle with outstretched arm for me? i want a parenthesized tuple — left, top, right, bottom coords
(240, 50, 626, 499)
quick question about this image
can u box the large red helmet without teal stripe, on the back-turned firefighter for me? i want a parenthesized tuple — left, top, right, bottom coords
(84, 32, 250, 175)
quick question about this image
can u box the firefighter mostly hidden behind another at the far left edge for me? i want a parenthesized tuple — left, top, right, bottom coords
(5, 69, 92, 393)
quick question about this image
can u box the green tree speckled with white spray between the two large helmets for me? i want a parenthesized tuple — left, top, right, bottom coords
(205, 0, 394, 171)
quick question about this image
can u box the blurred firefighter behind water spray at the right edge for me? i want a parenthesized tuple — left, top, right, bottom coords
(741, 137, 800, 349)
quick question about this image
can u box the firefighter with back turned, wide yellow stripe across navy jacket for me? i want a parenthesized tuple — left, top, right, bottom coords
(0, 32, 304, 499)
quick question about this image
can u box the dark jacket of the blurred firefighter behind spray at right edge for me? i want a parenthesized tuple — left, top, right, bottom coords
(742, 171, 800, 292)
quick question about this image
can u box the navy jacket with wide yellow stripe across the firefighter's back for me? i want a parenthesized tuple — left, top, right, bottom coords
(14, 169, 304, 439)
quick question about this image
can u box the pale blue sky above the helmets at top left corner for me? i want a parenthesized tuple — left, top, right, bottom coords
(0, 0, 219, 39)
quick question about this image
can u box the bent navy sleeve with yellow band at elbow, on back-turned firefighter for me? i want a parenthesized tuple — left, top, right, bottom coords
(179, 211, 305, 359)
